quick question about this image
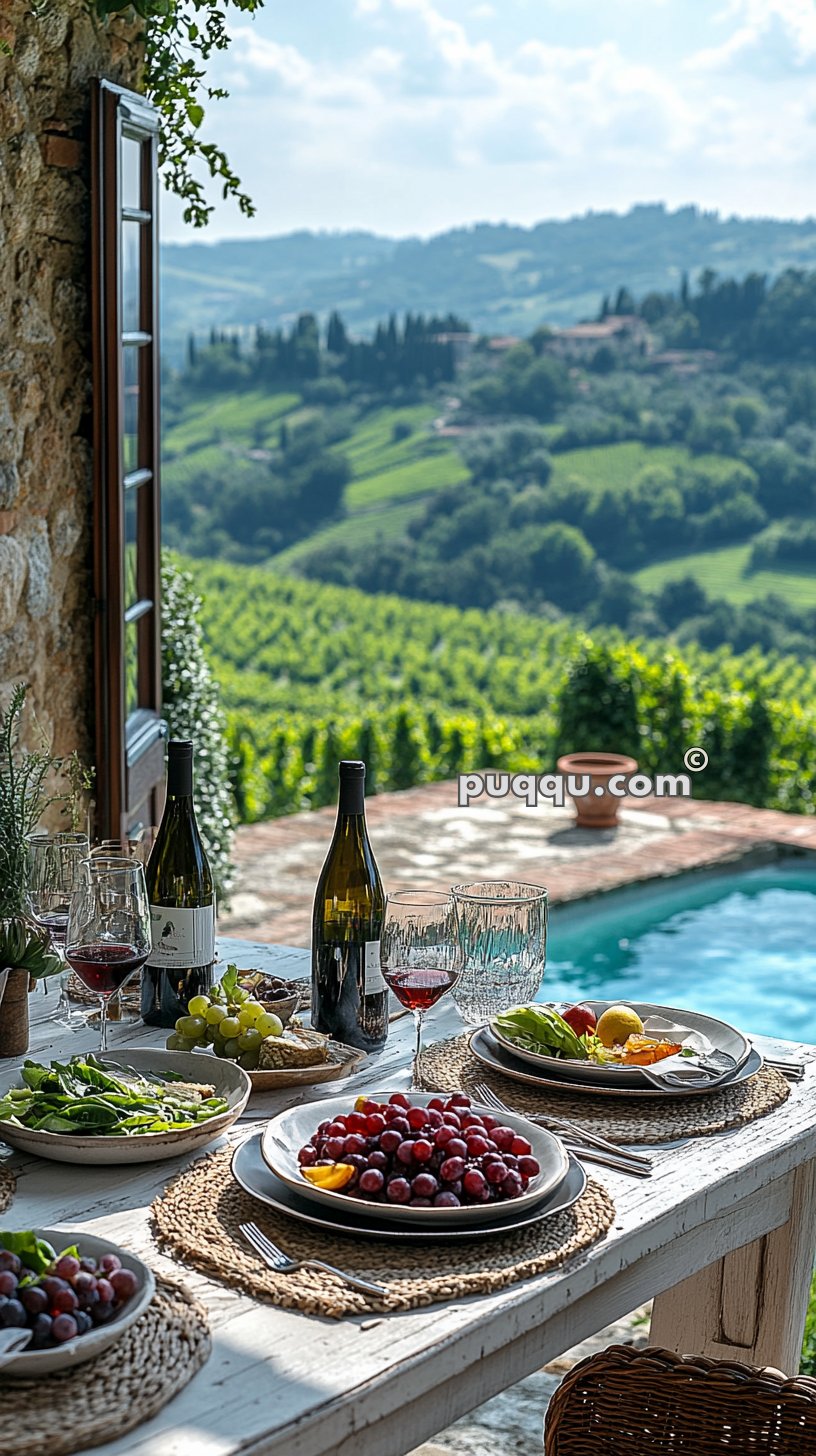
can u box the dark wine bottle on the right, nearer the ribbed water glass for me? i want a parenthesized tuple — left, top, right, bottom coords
(312, 760, 388, 1051)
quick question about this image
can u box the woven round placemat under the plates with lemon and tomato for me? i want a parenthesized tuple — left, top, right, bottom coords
(421, 1031, 790, 1143)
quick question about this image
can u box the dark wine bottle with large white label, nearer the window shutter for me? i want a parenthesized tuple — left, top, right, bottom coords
(141, 740, 216, 1026)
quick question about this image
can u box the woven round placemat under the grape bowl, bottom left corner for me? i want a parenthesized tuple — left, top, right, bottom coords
(0, 1278, 210, 1456)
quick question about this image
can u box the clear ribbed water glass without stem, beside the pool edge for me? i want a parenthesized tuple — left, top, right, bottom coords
(452, 879, 548, 1026)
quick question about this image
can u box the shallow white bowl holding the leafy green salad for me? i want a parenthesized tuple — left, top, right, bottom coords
(0, 1047, 252, 1163)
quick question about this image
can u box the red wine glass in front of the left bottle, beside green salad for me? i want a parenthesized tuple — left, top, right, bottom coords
(66, 858, 150, 1053)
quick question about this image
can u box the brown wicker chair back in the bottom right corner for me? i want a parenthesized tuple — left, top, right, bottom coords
(544, 1345, 816, 1456)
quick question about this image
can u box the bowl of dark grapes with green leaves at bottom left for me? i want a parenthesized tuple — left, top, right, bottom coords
(0, 1229, 156, 1379)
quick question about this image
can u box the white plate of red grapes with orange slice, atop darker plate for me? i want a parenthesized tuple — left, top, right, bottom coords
(261, 1092, 568, 1227)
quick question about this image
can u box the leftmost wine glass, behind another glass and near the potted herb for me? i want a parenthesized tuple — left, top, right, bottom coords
(26, 830, 90, 1029)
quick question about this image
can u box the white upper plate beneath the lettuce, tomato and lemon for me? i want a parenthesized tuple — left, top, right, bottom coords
(488, 1000, 750, 1092)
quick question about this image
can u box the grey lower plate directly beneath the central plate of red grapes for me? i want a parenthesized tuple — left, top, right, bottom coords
(232, 1133, 586, 1243)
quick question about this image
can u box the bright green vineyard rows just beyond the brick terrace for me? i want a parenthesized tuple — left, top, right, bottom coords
(184, 561, 816, 821)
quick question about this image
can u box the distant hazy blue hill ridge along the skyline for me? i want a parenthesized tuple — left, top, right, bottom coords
(162, 204, 816, 364)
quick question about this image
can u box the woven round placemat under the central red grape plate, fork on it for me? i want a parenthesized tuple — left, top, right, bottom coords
(153, 1147, 615, 1319)
